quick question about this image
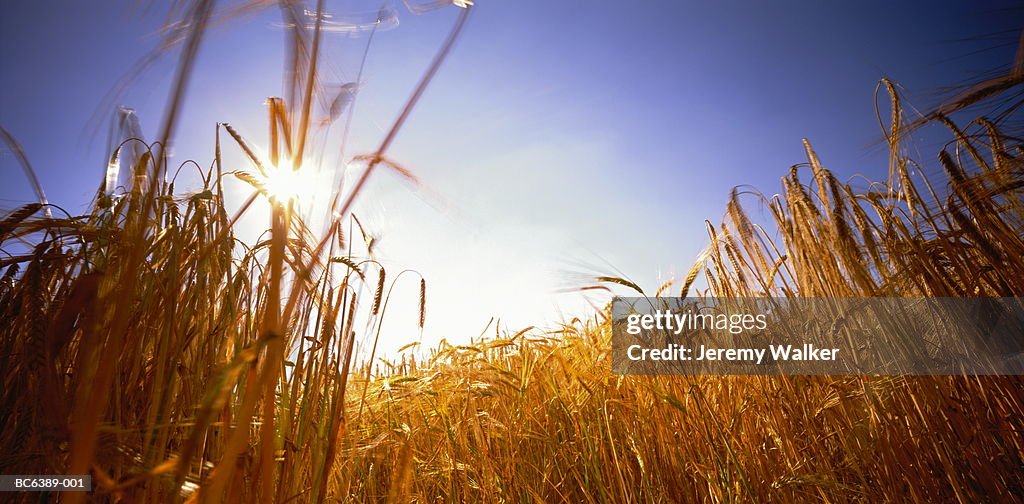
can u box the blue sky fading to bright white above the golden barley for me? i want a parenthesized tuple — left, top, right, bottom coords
(0, 0, 1024, 348)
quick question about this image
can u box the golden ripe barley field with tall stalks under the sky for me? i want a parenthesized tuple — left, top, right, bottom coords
(0, 0, 1024, 503)
